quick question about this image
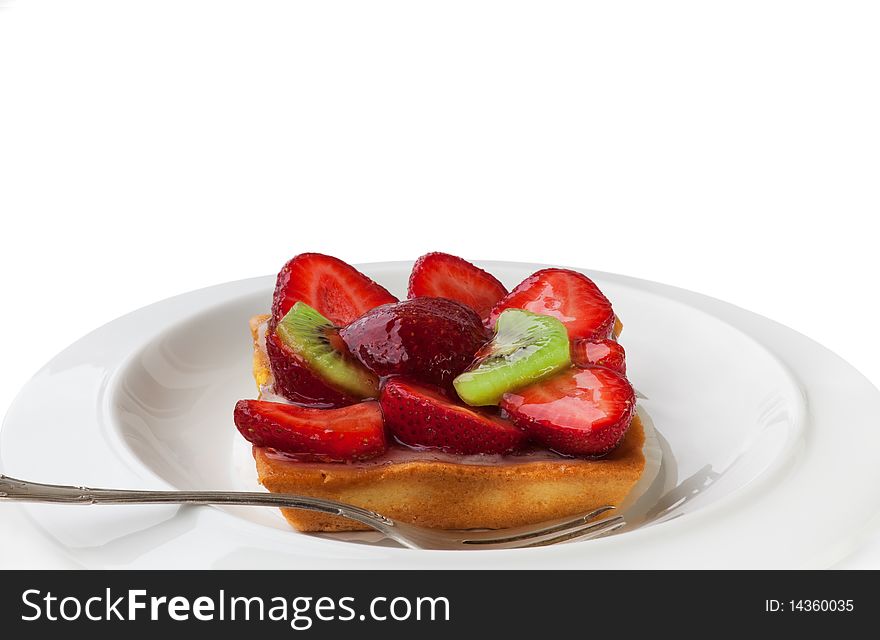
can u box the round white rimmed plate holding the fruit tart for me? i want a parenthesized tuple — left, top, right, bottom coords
(0, 263, 880, 568)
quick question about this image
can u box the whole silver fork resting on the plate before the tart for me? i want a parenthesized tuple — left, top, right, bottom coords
(0, 475, 626, 550)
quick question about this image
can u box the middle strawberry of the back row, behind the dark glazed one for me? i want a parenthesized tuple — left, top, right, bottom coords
(408, 252, 507, 318)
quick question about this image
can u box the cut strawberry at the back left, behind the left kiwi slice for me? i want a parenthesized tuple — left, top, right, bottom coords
(270, 253, 397, 327)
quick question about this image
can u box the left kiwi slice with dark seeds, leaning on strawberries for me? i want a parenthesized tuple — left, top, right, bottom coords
(275, 302, 379, 398)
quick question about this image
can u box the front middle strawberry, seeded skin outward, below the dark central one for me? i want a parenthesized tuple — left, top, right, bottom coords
(379, 378, 526, 455)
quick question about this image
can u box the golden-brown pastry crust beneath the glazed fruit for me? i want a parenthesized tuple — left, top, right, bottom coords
(250, 316, 645, 532)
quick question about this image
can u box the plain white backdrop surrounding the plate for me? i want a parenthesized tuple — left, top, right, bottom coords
(0, 0, 880, 568)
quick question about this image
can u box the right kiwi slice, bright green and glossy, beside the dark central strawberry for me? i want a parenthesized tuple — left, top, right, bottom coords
(452, 309, 571, 406)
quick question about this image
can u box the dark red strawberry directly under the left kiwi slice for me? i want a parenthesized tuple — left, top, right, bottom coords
(266, 331, 361, 409)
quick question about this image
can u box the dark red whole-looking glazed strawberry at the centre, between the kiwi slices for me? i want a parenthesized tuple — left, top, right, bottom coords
(339, 298, 489, 387)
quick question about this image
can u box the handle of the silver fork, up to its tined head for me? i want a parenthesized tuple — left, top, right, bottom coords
(0, 474, 394, 534)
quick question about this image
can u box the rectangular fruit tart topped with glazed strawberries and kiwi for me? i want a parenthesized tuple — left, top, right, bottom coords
(234, 253, 645, 531)
